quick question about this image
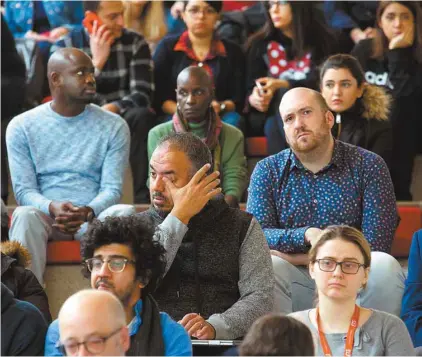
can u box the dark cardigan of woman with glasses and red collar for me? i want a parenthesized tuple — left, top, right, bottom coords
(153, 35, 245, 113)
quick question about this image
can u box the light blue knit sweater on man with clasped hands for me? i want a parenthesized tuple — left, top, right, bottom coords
(6, 103, 130, 216)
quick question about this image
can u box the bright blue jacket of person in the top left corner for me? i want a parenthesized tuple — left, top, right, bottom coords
(4, 0, 84, 38)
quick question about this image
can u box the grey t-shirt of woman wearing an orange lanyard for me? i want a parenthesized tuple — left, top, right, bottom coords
(289, 310, 415, 356)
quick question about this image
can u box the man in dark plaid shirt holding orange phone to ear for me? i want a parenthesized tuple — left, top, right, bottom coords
(52, 0, 156, 203)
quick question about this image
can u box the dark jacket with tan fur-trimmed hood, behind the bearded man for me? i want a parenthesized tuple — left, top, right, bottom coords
(331, 85, 393, 167)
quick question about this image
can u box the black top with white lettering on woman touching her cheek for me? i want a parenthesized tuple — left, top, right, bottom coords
(352, 39, 422, 201)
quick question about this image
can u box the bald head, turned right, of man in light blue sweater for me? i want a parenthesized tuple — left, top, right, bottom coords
(47, 48, 96, 106)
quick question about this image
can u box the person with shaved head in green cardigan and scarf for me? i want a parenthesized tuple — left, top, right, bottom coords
(148, 67, 247, 207)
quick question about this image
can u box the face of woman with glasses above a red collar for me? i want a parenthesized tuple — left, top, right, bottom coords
(182, 0, 220, 37)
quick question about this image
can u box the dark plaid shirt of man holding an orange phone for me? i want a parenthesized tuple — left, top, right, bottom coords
(51, 27, 154, 114)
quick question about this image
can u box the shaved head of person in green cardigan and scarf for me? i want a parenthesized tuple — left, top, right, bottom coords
(176, 66, 214, 123)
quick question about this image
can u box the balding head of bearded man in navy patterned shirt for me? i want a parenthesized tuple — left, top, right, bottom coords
(280, 88, 334, 154)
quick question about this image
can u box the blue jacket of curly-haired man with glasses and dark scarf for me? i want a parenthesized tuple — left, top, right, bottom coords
(44, 300, 192, 356)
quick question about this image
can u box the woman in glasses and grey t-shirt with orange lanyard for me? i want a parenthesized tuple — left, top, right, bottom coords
(290, 226, 414, 356)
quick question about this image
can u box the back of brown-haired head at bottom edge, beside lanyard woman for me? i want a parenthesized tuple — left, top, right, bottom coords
(239, 314, 315, 356)
